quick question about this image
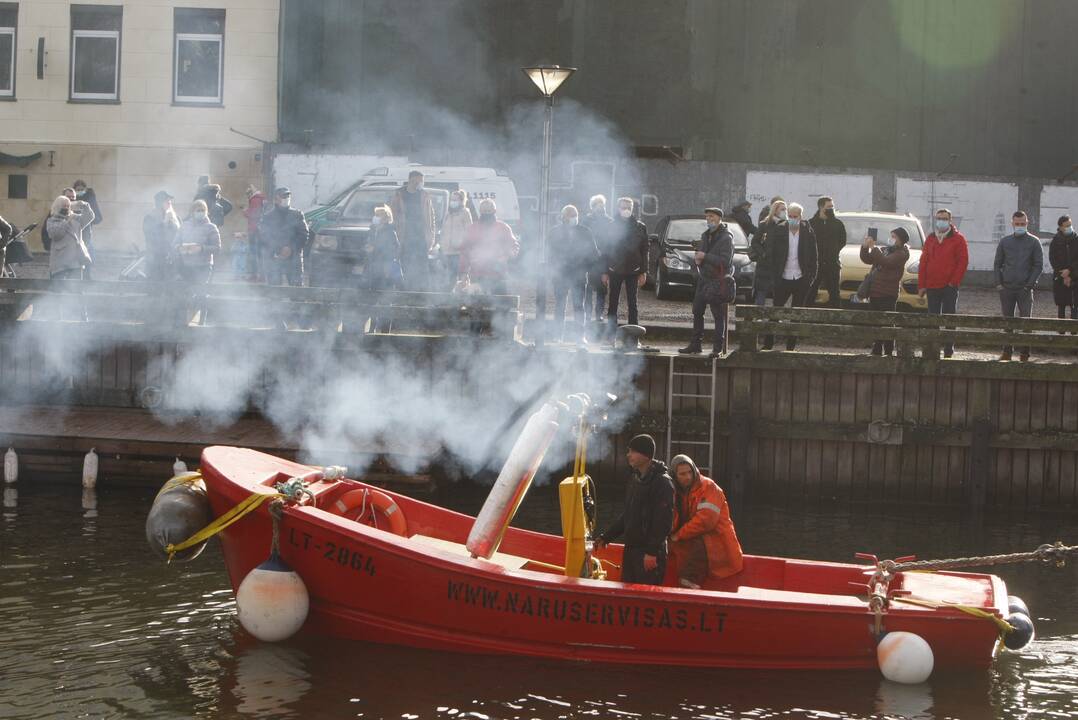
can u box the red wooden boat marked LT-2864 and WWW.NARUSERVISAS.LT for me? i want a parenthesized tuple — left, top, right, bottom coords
(202, 447, 1008, 669)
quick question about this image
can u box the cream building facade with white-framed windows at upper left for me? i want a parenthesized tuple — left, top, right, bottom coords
(0, 0, 278, 250)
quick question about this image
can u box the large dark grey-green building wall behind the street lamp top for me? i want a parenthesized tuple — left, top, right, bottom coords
(281, 0, 1078, 178)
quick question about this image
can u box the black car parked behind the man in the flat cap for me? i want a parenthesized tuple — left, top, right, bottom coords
(648, 214, 756, 301)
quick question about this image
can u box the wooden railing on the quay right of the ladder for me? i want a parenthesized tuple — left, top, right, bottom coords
(735, 305, 1078, 359)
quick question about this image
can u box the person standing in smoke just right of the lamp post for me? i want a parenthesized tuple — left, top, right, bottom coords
(547, 205, 599, 343)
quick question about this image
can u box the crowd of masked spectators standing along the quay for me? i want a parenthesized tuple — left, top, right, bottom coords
(6, 178, 1078, 361)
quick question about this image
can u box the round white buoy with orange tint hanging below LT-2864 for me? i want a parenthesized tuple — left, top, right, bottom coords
(236, 553, 310, 642)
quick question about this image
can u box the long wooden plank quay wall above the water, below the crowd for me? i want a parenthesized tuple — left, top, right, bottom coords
(0, 281, 1078, 511)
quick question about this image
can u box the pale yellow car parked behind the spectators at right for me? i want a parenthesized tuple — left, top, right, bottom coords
(816, 211, 928, 310)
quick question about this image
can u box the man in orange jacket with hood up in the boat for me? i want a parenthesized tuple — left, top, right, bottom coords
(669, 455, 742, 587)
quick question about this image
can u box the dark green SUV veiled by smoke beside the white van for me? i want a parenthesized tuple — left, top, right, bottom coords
(307, 184, 450, 288)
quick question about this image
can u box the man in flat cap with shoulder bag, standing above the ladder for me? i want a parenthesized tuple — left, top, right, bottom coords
(678, 208, 736, 358)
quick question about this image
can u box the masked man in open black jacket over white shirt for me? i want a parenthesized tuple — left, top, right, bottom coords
(763, 203, 817, 350)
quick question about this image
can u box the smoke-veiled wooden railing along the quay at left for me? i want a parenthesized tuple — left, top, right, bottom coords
(0, 279, 520, 340)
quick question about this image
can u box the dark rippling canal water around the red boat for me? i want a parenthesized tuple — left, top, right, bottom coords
(0, 479, 1078, 720)
